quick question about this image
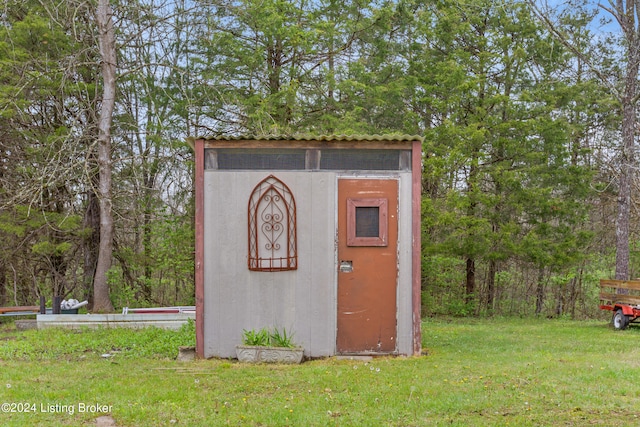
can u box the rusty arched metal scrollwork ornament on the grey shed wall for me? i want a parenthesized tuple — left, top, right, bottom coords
(248, 175, 298, 271)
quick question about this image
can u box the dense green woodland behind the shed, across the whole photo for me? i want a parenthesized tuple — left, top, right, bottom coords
(0, 0, 640, 318)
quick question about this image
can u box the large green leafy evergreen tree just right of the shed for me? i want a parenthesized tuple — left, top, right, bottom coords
(419, 0, 589, 311)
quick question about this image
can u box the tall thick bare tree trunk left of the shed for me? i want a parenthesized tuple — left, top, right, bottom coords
(93, 0, 116, 312)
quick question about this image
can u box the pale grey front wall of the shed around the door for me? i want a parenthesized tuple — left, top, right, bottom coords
(203, 171, 412, 358)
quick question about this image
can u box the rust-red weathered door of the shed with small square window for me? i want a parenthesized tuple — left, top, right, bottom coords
(336, 179, 398, 354)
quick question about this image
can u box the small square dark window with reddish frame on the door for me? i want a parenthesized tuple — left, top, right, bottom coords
(347, 198, 388, 246)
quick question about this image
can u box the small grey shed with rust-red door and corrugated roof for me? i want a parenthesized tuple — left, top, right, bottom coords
(190, 135, 422, 358)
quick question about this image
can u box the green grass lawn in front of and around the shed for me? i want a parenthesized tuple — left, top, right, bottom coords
(0, 319, 640, 426)
